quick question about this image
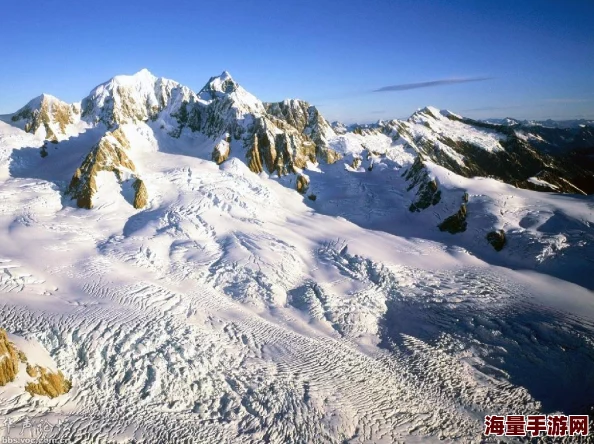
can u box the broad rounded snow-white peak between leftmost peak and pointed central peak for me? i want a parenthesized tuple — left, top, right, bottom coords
(81, 69, 196, 128)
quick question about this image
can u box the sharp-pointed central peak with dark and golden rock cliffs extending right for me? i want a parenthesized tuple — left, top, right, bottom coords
(178, 72, 338, 176)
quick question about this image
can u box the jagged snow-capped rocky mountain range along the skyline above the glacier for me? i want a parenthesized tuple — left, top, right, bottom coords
(4, 70, 594, 208)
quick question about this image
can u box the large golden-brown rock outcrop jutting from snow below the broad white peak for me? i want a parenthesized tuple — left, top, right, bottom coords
(67, 128, 137, 209)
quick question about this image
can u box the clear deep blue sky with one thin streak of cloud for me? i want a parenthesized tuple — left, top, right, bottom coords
(0, 0, 594, 123)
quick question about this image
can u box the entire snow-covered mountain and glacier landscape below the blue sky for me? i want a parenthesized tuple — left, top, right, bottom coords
(0, 70, 594, 442)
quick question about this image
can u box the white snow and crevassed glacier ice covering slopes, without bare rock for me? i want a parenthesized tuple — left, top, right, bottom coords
(0, 72, 594, 443)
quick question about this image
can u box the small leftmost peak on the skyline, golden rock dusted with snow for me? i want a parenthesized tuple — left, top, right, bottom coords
(11, 94, 80, 141)
